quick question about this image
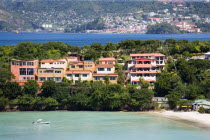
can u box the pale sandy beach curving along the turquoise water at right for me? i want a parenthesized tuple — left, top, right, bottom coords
(148, 111, 210, 129)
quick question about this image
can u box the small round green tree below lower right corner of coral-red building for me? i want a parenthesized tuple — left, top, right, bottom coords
(23, 80, 39, 96)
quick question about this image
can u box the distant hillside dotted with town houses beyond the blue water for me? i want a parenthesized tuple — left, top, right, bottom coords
(0, 0, 210, 34)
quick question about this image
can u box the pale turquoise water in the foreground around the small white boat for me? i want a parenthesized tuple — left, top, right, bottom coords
(0, 111, 210, 140)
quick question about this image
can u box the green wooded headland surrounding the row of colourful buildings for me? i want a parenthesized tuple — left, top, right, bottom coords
(0, 39, 210, 111)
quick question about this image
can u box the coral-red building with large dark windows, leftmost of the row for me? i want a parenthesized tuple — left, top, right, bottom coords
(11, 59, 39, 85)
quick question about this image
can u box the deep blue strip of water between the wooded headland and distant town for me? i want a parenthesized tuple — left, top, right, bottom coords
(0, 32, 210, 46)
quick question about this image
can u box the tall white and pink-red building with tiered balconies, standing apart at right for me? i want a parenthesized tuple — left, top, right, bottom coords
(127, 53, 165, 85)
